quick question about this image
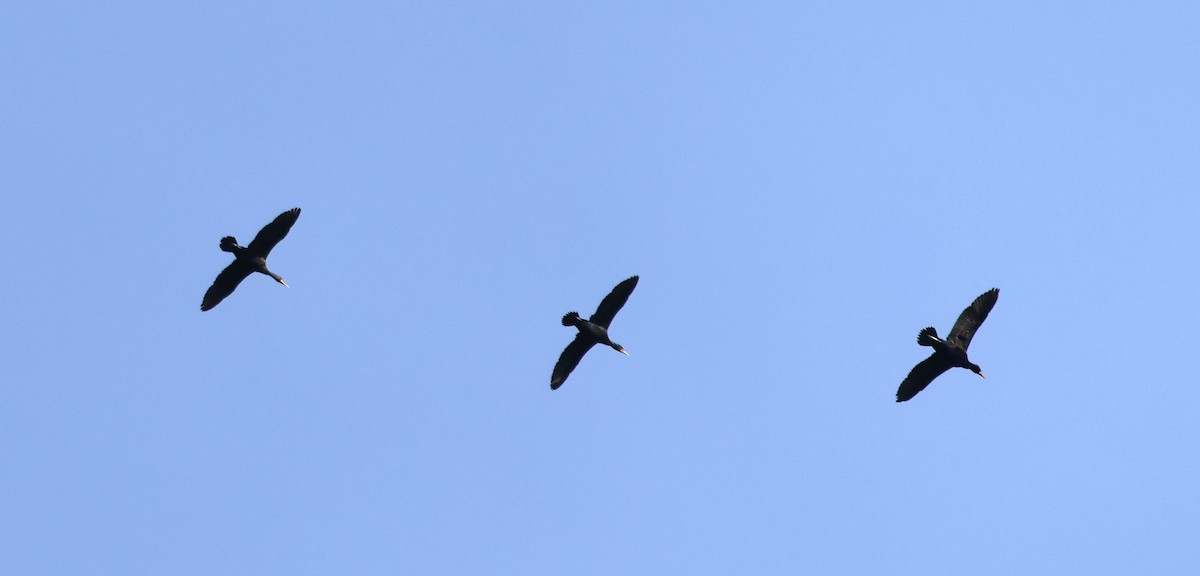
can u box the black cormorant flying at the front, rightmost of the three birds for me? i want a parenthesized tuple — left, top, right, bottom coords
(896, 288, 1000, 402)
